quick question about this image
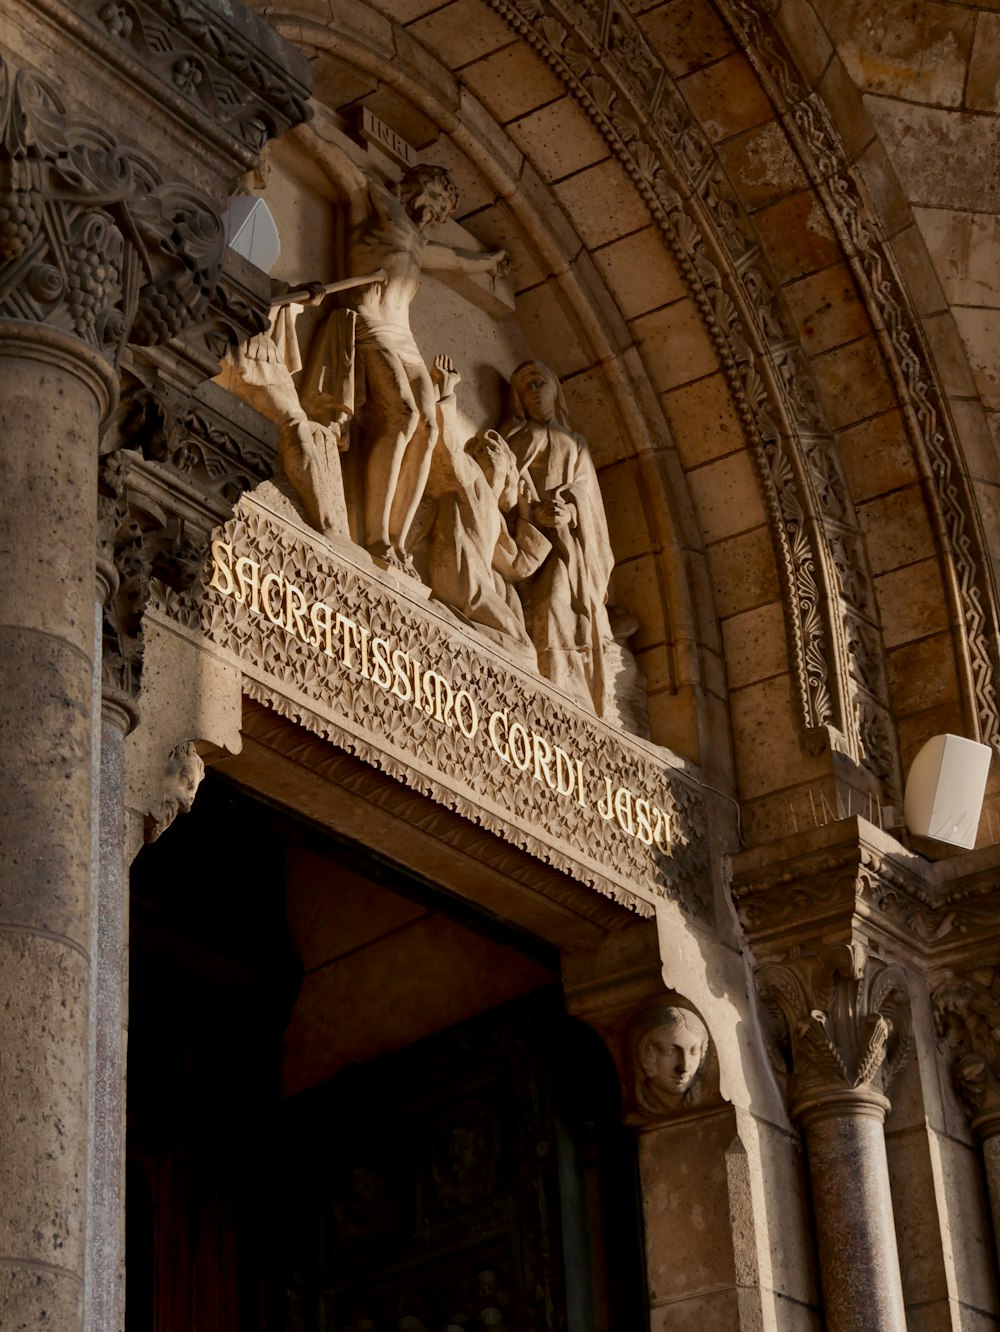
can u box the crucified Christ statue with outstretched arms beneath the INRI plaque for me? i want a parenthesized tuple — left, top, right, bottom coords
(297, 128, 510, 577)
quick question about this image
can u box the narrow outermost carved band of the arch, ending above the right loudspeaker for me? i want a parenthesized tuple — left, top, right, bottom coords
(718, 0, 1000, 749)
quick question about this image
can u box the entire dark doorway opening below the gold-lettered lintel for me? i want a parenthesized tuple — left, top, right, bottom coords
(126, 777, 646, 1332)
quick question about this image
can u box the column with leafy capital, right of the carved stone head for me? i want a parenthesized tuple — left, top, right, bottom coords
(756, 943, 911, 1332)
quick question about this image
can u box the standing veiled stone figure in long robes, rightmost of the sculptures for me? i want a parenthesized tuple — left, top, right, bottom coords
(501, 361, 614, 713)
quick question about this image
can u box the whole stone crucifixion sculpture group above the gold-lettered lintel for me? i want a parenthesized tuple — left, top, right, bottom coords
(225, 132, 646, 734)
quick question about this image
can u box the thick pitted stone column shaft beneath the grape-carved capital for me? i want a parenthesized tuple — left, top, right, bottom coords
(0, 321, 117, 1332)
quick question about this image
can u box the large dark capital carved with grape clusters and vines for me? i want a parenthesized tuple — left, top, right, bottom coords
(0, 57, 224, 365)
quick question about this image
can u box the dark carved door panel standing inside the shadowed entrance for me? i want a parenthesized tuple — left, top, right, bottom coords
(288, 992, 577, 1332)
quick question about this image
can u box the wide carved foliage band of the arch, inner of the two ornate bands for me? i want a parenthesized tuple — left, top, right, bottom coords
(476, 0, 899, 783)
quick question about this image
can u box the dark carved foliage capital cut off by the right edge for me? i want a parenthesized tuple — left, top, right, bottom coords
(931, 967, 1000, 1138)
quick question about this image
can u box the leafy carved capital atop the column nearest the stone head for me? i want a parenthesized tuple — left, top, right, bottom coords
(756, 943, 912, 1114)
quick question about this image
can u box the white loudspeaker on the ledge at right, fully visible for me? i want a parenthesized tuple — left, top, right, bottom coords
(903, 735, 993, 847)
